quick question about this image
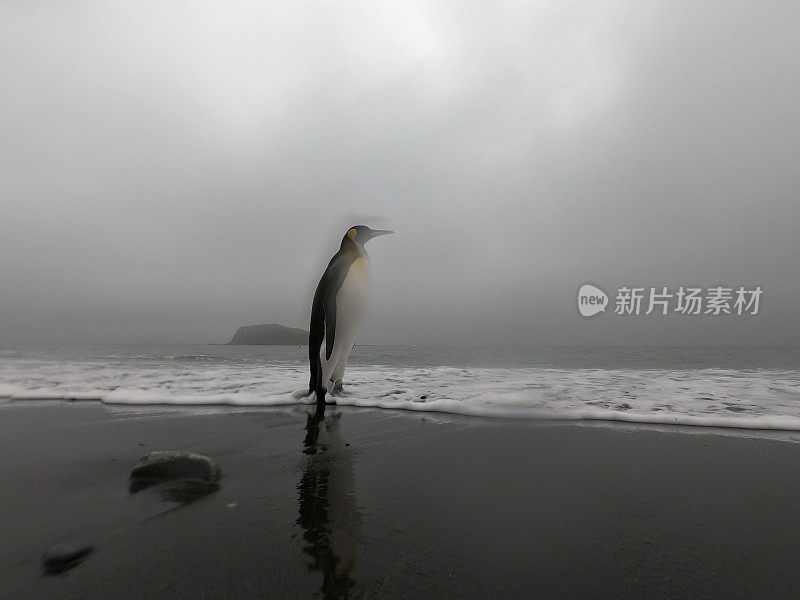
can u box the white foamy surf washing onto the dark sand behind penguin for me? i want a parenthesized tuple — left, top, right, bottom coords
(0, 355, 800, 431)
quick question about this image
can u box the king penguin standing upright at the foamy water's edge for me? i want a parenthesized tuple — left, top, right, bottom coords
(308, 225, 394, 404)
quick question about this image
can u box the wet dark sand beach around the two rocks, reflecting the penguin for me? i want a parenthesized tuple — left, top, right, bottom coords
(0, 402, 800, 599)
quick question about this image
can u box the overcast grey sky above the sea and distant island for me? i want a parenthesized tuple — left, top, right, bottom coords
(0, 0, 800, 345)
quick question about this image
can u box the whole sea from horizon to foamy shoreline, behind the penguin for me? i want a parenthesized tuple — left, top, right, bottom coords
(0, 345, 800, 431)
